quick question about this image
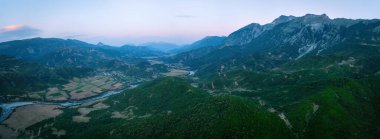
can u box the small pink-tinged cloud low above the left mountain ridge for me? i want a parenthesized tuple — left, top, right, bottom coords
(0, 24, 42, 42)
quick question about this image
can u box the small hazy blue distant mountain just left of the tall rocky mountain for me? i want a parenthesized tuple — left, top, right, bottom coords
(169, 36, 226, 53)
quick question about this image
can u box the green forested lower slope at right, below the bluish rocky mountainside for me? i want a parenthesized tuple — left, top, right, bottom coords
(197, 40, 380, 138)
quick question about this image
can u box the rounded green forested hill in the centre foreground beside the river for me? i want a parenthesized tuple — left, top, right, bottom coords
(23, 78, 293, 138)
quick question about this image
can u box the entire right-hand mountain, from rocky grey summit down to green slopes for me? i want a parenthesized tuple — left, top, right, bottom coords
(167, 14, 380, 138)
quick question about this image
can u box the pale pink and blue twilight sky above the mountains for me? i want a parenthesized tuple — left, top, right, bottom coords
(0, 0, 380, 46)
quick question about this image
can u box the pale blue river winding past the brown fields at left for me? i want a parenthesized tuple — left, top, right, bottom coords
(0, 85, 138, 124)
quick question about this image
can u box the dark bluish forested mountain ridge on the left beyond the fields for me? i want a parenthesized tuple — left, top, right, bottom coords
(0, 38, 161, 67)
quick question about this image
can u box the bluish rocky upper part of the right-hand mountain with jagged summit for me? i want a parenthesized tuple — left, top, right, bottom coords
(171, 14, 380, 74)
